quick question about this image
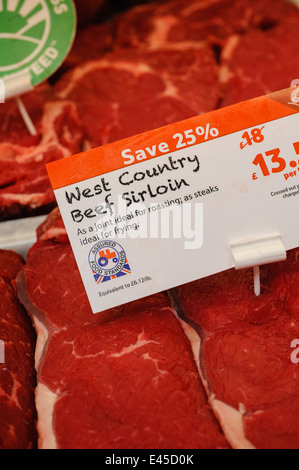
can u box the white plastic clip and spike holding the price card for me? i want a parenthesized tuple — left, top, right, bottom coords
(231, 233, 287, 295)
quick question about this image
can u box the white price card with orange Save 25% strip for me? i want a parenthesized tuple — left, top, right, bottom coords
(47, 88, 299, 313)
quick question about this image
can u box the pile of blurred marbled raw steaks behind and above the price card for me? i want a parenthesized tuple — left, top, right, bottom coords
(0, 0, 299, 220)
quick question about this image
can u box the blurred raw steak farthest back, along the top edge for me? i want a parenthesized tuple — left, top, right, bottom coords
(116, 0, 298, 48)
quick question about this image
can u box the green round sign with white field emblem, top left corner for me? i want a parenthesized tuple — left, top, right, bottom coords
(0, 0, 76, 85)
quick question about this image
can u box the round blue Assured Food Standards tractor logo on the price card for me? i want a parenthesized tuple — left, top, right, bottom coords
(88, 240, 131, 284)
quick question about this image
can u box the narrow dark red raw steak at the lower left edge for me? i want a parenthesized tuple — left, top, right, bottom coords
(0, 250, 37, 449)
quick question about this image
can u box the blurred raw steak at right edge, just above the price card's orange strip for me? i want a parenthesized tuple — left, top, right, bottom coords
(220, 17, 299, 106)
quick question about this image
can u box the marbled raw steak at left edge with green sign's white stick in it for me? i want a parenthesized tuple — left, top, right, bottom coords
(0, 85, 82, 221)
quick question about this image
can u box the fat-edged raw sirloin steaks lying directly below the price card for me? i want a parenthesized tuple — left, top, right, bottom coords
(17, 209, 299, 449)
